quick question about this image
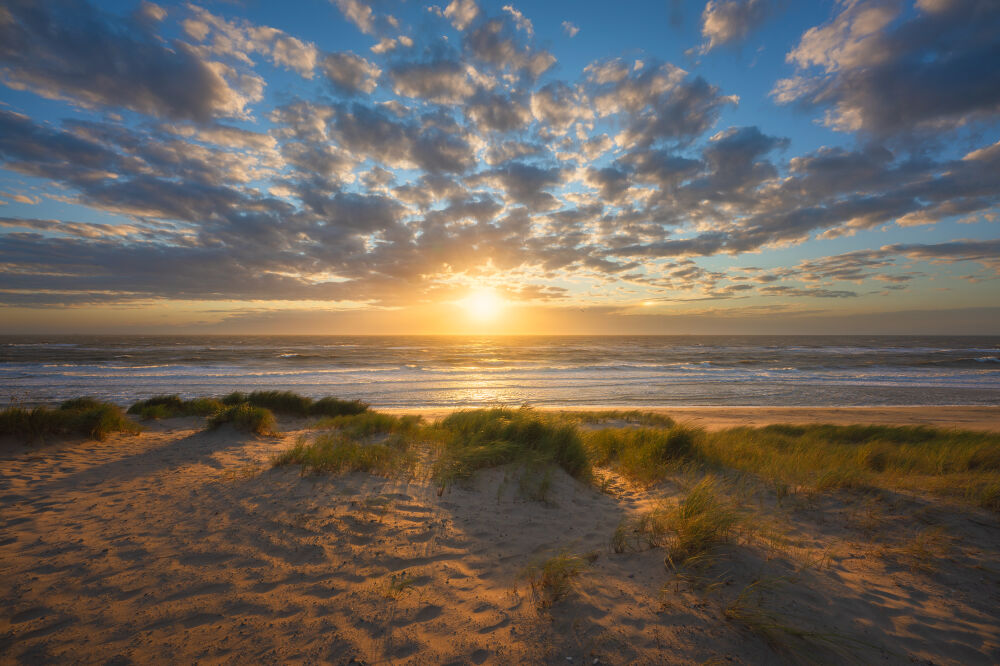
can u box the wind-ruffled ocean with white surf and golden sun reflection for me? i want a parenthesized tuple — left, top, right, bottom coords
(0, 336, 1000, 407)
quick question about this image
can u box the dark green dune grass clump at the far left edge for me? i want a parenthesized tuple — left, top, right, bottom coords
(0, 398, 142, 441)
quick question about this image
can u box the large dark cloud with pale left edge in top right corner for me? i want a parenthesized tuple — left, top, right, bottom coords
(772, 0, 1000, 137)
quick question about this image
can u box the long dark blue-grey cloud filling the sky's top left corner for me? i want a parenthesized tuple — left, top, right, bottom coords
(0, 0, 263, 122)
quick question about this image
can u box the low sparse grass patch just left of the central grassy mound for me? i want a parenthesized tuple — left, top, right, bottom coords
(271, 432, 416, 476)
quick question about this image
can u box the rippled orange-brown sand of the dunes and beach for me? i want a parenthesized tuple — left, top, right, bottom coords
(0, 409, 1000, 664)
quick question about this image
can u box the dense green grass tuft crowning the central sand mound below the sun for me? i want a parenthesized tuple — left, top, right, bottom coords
(433, 407, 591, 484)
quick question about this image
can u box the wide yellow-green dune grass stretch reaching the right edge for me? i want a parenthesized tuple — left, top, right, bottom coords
(581, 425, 1000, 511)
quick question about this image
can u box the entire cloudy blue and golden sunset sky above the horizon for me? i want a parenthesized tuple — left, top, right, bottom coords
(0, 0, 1000, 334)
